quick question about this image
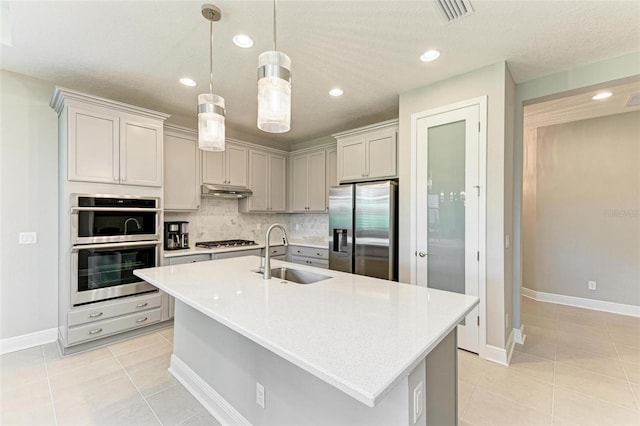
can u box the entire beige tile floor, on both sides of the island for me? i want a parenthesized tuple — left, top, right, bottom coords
(0, 298, 640, 426)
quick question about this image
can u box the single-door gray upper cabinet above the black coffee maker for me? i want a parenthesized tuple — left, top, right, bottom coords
(164, 126, 200, 211)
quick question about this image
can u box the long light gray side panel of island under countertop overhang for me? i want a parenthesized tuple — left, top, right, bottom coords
(172, 300, 413, 426)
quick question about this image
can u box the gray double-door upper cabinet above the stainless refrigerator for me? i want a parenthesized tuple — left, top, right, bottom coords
(333, 120, 398, 182)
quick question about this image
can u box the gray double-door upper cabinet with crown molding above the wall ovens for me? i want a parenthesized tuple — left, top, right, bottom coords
(51, 88, 169, 187)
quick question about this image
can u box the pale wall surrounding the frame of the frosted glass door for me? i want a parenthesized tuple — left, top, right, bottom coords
(398, 63, 513, 349)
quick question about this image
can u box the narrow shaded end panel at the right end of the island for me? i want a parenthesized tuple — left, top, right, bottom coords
(426, 328, 458, 426)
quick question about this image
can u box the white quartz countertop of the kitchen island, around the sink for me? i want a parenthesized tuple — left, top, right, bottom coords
(134, 256, 478, 407)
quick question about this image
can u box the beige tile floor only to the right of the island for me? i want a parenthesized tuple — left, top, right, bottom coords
(458, 298, 640, 426)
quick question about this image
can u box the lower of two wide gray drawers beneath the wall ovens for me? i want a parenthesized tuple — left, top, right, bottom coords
(67, 308, 162, 345)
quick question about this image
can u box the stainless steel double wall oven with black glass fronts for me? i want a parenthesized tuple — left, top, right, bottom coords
(71, 194, 161, 306)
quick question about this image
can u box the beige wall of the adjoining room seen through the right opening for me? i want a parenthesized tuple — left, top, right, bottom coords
(523, 111, 640, 305)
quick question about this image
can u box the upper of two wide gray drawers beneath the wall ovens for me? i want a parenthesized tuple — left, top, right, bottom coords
(69, 293, 162, 327)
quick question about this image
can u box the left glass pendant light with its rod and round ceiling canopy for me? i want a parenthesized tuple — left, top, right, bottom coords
(198, 4, 225, 151)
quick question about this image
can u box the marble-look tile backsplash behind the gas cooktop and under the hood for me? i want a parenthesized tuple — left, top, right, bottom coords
(164, 197, 329, 246)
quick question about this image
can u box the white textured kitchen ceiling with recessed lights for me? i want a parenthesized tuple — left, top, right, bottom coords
(0, 0, 640, 146)
